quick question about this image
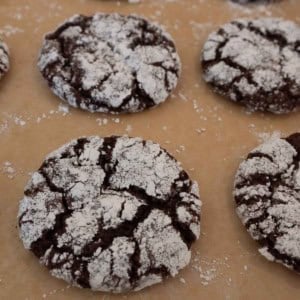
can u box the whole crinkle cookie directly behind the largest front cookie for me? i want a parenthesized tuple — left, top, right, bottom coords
(38, 13, 181, 113)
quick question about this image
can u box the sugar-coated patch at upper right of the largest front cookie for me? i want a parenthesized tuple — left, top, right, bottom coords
(111, 139, 180, 198)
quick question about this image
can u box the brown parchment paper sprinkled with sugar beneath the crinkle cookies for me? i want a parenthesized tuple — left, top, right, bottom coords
(0, 0, 300, 300)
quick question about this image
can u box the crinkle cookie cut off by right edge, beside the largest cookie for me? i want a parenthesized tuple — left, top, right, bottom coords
(234, 133, 300, 272)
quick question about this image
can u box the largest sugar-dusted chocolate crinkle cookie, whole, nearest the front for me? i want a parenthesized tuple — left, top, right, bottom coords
(18, 136, 201, 292)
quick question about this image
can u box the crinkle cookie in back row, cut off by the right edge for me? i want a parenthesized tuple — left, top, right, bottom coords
(202, 18, 300, 114)
